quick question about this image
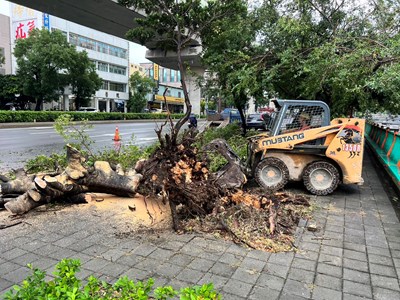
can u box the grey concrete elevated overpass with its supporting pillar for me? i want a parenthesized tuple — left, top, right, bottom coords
(9, 0, 204, 113)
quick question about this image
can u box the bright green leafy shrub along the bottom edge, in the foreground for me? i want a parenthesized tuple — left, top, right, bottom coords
(3, 259, 222, 300)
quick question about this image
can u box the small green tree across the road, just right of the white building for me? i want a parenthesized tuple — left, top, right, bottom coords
(128, 72, 156, 113)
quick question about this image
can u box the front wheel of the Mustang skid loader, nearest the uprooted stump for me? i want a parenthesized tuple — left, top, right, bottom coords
(254, 157, 289, 191)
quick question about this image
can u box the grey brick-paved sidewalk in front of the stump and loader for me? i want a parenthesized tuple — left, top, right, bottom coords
(0, 151, 400, 300)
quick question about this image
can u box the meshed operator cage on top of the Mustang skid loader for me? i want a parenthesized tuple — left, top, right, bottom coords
(272, 100, 331, 136)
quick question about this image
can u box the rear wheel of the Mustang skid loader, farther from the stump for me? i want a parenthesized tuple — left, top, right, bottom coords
(303, 161, 340, 195)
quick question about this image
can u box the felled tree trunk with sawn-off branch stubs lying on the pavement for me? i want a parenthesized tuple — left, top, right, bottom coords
(0, 145, 142, 215)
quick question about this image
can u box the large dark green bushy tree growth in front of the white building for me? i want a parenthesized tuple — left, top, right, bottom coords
(14, 29, 101, 110)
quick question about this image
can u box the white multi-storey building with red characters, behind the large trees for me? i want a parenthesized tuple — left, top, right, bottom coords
(10, 4, 129, 112)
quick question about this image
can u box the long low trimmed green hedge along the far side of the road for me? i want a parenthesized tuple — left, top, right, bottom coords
(0, 110, 183, 123)
